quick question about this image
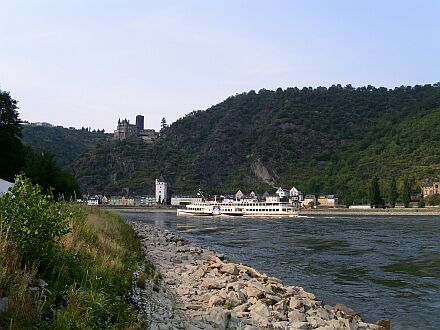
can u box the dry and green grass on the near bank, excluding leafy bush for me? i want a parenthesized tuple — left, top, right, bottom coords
(0, 205, 142, 329)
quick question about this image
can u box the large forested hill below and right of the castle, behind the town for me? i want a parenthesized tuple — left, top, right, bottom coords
(74, 84, 440, 202)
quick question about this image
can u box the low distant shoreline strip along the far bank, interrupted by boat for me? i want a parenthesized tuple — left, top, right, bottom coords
(100, 206, 440, 217)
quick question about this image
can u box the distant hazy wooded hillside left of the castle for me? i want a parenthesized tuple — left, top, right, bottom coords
(22, 125, 109, 170)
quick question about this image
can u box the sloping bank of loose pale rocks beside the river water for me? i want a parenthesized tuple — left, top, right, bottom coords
(125, 222, 384, 330)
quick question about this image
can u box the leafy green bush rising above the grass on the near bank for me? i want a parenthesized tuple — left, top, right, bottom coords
(0, 175, 69, 262)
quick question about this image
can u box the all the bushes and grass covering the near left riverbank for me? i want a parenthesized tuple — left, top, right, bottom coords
(0, 178, 141, 329)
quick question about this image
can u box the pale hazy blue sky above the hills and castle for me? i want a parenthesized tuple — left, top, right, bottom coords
(0, 0, 440, 131)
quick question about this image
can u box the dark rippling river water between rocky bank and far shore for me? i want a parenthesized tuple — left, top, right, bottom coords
(122, 213, 440, 329)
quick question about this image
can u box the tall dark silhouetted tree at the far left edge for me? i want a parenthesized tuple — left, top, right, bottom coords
(0, 90, 23, 181)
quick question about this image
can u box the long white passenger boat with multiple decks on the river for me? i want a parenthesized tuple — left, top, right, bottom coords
(177, 201, 298, 217)
